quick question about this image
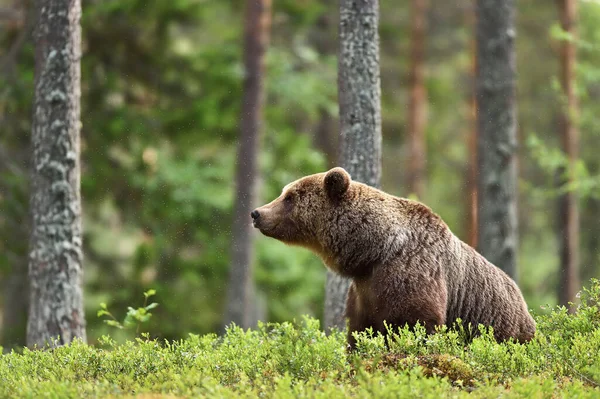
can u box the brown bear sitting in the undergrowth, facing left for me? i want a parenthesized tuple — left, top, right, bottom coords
(251, 168, 535, 348)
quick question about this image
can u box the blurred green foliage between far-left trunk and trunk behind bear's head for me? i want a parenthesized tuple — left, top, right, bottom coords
(74, 0, 336, 341)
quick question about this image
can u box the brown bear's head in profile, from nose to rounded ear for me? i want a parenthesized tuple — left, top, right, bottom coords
(250, 168, 352, 252)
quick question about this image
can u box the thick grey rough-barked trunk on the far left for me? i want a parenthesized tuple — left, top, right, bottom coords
(27, 0, 86, 347)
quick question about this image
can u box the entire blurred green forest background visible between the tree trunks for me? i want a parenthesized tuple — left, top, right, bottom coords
(0, 0, 600, 348)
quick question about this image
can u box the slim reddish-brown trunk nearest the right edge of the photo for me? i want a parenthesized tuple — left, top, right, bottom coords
(557, 0, 579, 311)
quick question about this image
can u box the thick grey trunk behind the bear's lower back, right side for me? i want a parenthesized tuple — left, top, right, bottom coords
(476, 0, 517, 279)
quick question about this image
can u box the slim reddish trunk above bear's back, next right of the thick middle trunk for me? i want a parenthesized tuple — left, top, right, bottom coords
(408, 0, 428, 199)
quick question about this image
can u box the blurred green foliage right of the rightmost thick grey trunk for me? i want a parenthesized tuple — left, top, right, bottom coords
(517, 1, 600, 300)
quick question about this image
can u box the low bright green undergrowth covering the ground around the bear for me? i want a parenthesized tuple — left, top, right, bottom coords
(0, 280, 600, 398)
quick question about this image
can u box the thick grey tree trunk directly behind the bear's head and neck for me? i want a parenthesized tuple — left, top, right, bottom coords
(325, 0, 381, 329)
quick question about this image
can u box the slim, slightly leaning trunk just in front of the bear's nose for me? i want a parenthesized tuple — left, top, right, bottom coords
(224, 0, 271, 328)
